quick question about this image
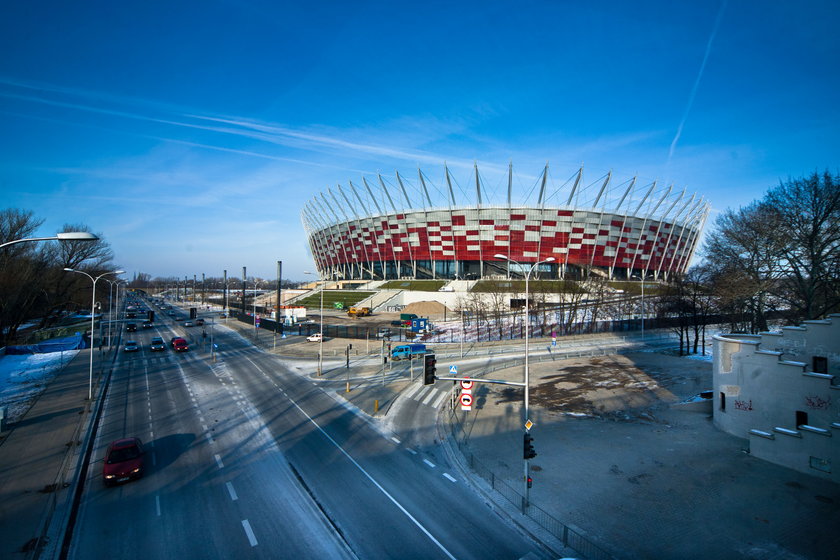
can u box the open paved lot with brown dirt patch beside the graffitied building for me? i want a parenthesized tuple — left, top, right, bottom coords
(459, 353, 840, 560)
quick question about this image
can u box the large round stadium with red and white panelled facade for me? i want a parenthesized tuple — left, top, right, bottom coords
(301, 166, 709, 279)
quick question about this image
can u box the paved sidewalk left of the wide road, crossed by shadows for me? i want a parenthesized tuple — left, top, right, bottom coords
(0, 350, 98, 559)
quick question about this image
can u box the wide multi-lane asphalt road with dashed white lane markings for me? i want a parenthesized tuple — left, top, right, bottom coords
(69, 300, 543, 559)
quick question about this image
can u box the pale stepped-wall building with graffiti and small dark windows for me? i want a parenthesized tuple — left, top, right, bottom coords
(713, 314, 840, 482)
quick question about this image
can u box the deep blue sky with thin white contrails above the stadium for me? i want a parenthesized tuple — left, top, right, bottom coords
(0, 0, 840, 280)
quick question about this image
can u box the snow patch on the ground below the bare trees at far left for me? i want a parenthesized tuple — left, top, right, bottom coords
(0, 350, 79, 422)
